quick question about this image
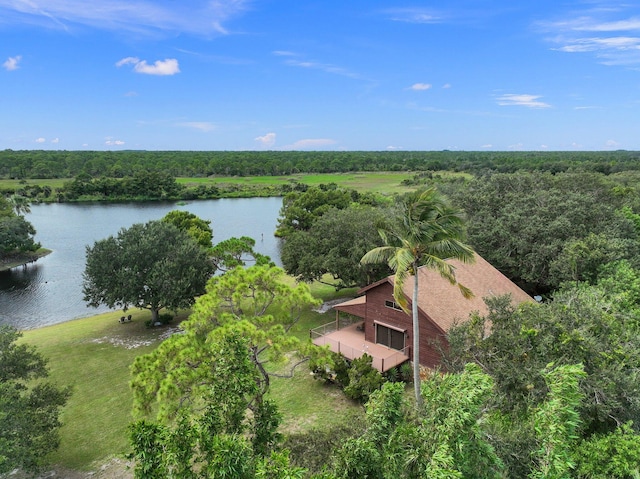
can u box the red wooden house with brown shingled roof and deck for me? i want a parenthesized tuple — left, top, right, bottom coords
(311, 254, 533, 372)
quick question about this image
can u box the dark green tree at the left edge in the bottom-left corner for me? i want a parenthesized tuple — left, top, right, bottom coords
(0, 326, 71, 475)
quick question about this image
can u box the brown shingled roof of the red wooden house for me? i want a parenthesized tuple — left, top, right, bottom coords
(350, 253, 533, 331)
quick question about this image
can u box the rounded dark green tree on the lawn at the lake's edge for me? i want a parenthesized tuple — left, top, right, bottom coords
(83, 221, 213, 323)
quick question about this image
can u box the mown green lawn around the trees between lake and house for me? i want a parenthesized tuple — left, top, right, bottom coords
(18, 285, 361, 470)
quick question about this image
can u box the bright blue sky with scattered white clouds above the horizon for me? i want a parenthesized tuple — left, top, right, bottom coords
(0, 0, 640, 151)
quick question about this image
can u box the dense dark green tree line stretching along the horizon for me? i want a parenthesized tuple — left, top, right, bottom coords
(0, 150, 640, 179)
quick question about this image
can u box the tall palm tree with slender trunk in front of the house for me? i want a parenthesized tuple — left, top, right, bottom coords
(360, 188, 475, 407)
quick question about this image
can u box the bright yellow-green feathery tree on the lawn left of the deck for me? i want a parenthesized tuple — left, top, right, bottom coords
(132, 266, 317, 418)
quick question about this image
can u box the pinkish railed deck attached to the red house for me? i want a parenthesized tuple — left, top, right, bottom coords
(311, 322, 409, 373)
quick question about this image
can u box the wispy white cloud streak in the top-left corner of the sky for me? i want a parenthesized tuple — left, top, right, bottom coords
(0, 0, 251, 36)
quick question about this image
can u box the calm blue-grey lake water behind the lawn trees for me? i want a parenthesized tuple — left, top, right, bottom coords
(0, 198, 282, 329)
